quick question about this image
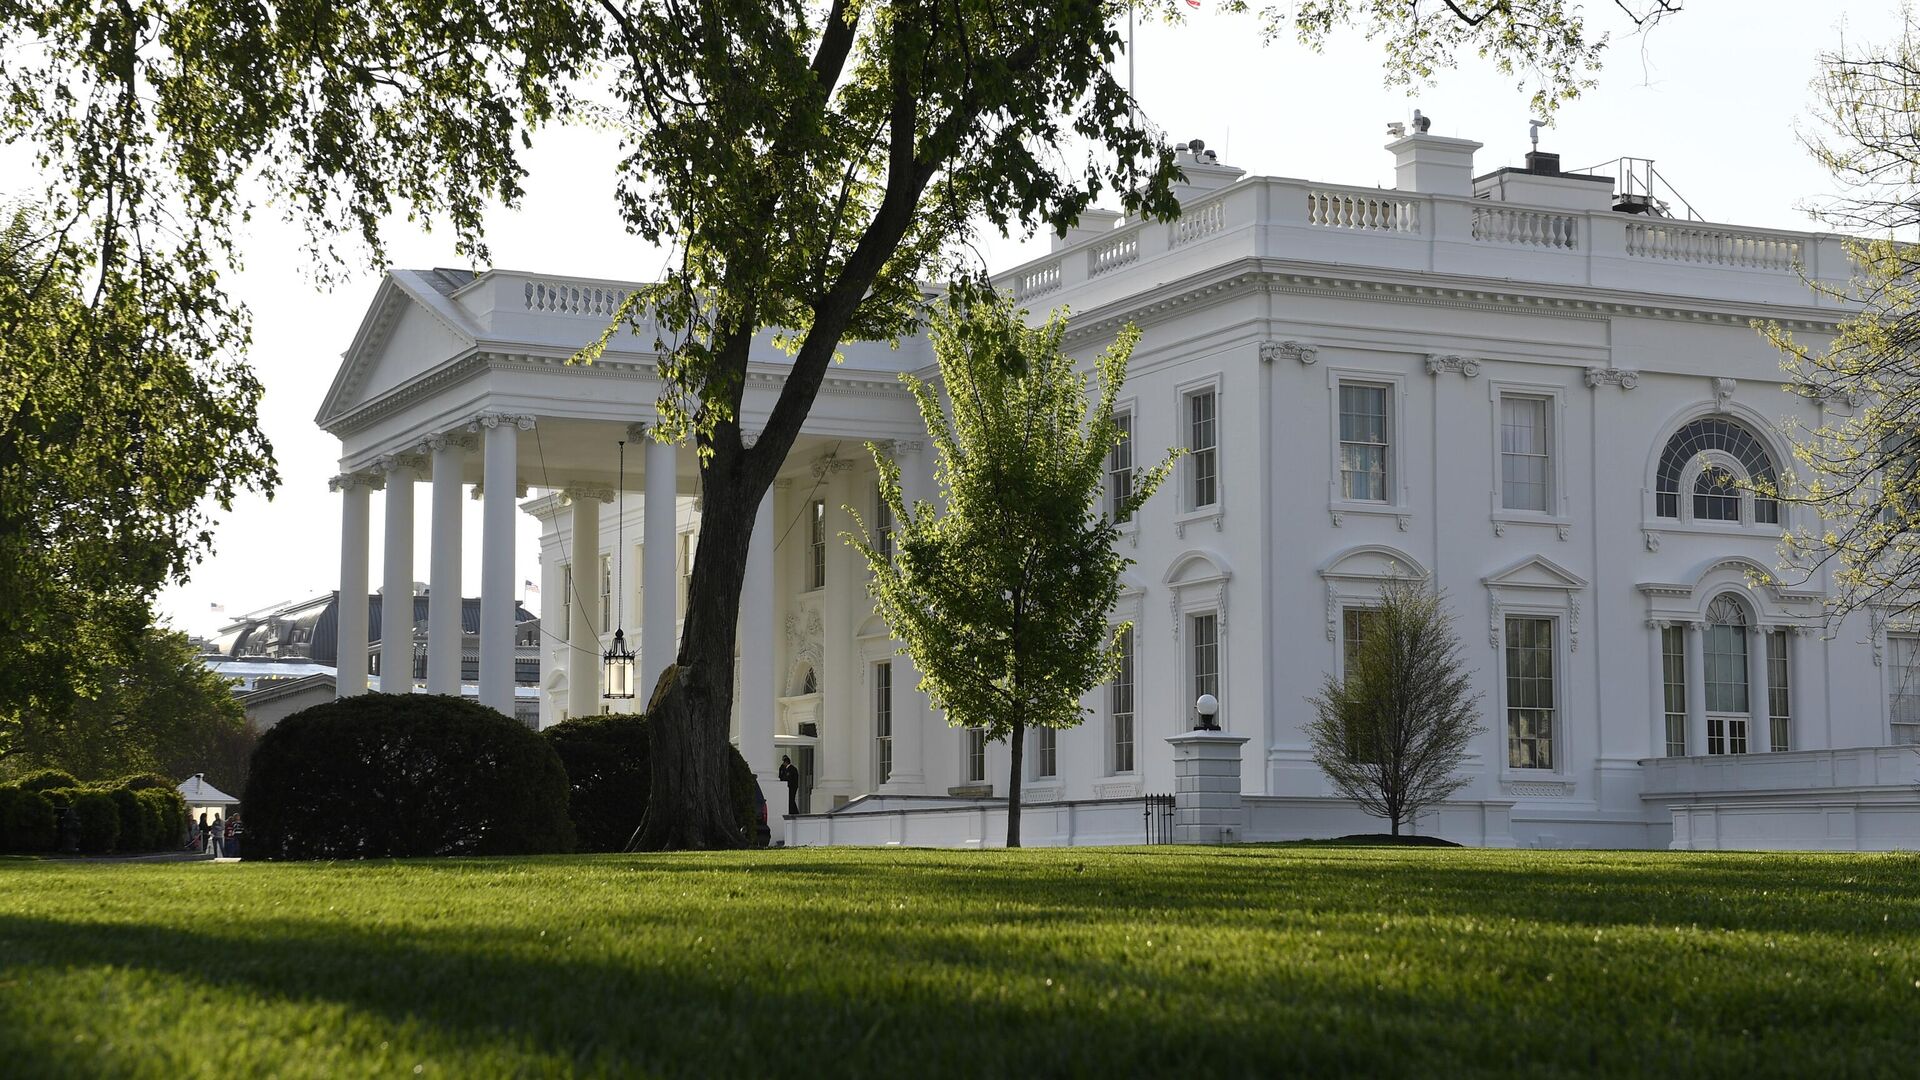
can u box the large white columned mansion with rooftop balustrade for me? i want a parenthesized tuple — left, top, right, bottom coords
(319, 135, 1920, 847)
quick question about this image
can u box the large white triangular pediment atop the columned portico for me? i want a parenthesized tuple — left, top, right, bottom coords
(315, 269, 478, 429)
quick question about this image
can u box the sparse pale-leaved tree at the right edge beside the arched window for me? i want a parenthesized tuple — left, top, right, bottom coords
(1755, 12, 1920, 617)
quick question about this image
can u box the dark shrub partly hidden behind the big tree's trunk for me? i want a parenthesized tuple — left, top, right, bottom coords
(540, 715, 760, 851)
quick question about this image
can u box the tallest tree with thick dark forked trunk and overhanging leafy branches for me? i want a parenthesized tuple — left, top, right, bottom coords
(0, 0, 1670, 847)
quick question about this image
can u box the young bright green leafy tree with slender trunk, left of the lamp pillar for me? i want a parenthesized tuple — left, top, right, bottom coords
(851, 292, 1175, 847)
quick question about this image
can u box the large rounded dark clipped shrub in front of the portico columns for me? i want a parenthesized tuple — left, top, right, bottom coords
(242, 694, 574, 859)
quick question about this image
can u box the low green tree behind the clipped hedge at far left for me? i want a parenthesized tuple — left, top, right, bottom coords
(0, 628, 252, 790)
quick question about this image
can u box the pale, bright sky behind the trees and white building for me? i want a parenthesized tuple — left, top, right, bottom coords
(86, 0, 1899, 634)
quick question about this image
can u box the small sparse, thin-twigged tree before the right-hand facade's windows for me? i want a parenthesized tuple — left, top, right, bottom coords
(1308, 578, 1484, 836)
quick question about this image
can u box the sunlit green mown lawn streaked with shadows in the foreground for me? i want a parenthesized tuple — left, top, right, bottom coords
(0, 847, 1920, 1078)
